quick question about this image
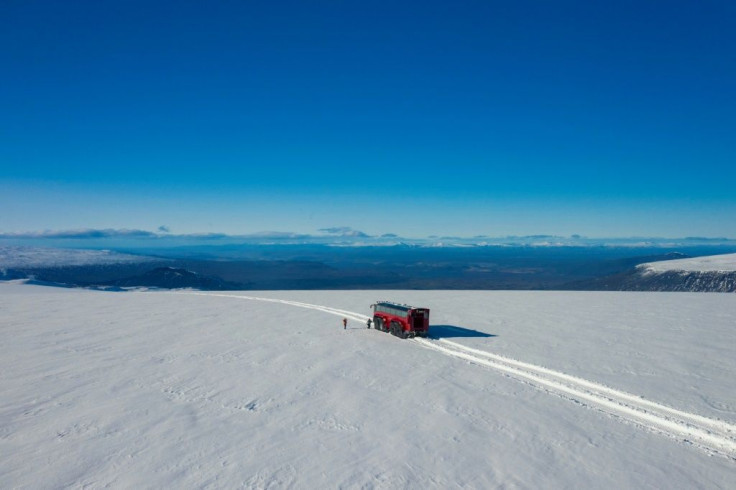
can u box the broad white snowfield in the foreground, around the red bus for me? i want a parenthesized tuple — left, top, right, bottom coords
(0, 283, 736, 488)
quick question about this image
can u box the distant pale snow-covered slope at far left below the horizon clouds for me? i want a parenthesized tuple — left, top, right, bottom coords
(0, 247, 159, 268)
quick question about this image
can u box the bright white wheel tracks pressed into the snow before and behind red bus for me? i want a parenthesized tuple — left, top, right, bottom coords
(175, 293, 736, 460)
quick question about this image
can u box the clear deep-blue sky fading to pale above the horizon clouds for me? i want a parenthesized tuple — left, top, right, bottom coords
(0, 0, 736, 237)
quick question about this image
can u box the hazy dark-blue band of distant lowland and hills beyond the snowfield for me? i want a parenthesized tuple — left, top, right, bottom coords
(0, 245, 736, 292)
